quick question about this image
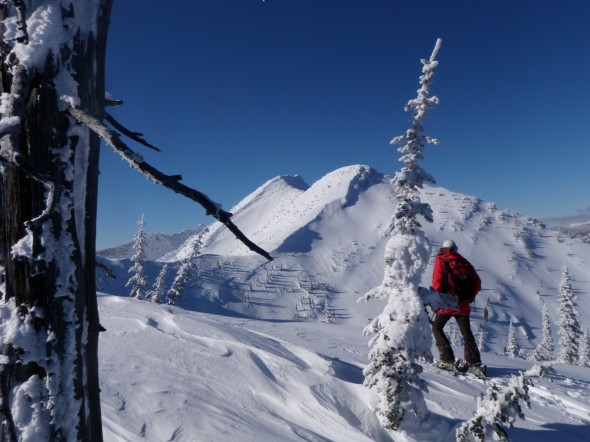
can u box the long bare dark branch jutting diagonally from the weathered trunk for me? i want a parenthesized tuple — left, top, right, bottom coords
(68, 108, 272, 261)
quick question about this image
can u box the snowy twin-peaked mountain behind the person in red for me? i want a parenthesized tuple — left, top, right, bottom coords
(98, 166, 590, 346)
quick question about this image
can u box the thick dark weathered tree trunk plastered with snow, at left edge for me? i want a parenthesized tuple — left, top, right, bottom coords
(0, 0, 112, 441)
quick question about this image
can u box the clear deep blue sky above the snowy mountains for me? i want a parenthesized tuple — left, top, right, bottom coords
(97, 0, 590, 249)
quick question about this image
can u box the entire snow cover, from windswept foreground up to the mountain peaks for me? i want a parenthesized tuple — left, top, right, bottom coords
(97, 166, 590, 442)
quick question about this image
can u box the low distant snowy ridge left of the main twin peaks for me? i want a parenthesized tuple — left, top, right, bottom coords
(96, 225, 204, 261)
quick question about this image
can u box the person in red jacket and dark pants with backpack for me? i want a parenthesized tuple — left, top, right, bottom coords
(432, 240, 481, 374)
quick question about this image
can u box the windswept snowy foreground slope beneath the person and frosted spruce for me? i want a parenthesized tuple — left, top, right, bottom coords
(99, 295, 590, 442)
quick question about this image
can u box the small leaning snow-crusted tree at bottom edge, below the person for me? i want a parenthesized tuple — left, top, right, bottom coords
(456, 373, 533, 442)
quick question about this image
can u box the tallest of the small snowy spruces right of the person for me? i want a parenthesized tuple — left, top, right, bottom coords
(557, 265, 582, 365)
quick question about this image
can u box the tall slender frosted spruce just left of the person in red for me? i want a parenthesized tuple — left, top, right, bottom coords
(361, 39, 441, 431)
